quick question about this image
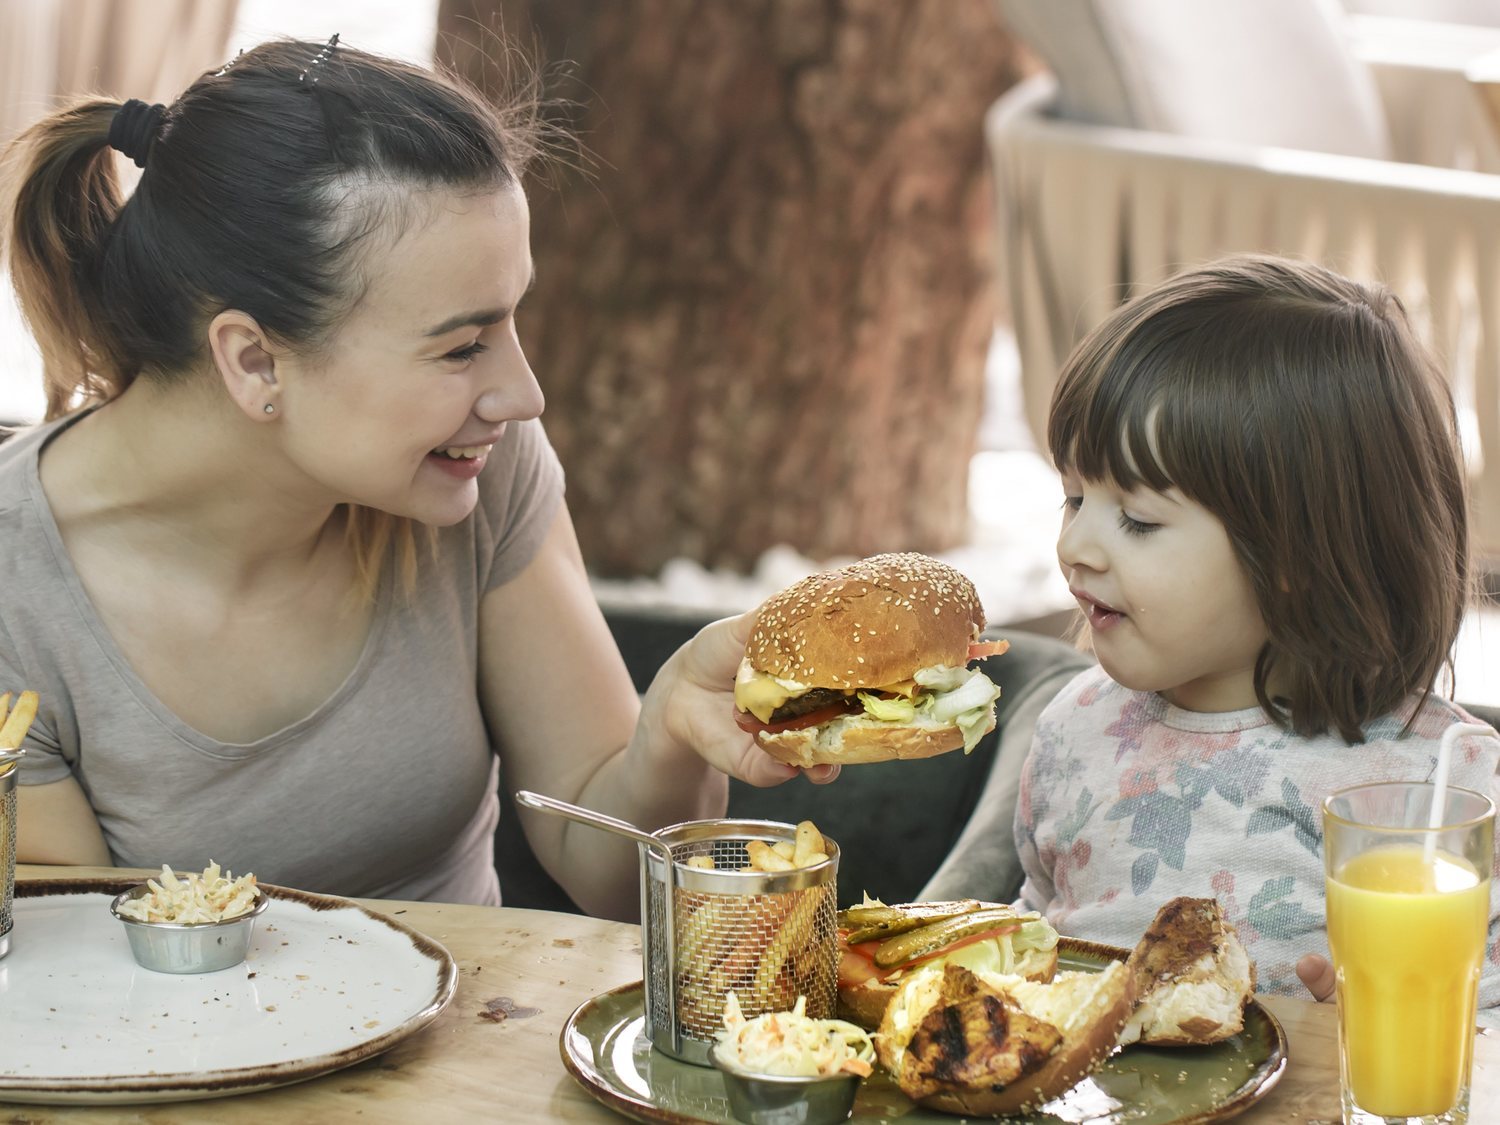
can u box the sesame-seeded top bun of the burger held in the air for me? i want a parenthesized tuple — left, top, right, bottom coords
(746, 554, 984, 690)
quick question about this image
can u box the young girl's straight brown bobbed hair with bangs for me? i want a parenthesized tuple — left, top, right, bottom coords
(1047, 257, 1470, 743)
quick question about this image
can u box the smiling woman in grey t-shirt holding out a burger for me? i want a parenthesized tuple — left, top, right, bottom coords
(0, 36, 831, 917)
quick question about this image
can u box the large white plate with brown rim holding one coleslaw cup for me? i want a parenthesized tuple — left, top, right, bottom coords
(0, 879, 458, 1103)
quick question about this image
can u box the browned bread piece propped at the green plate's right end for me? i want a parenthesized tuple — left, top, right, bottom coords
(1119, 899, 1256, 1047)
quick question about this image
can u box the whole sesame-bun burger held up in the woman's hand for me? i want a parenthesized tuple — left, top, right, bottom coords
(735, 554, 1010, 767)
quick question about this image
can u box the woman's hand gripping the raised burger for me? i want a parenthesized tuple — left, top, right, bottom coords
(636, 611, 839, 786)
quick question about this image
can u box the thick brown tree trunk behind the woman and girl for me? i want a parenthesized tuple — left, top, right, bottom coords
(440, 0, 1023, 575)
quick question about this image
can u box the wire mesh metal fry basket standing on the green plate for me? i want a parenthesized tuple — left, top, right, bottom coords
(639, 821, 839, 1067)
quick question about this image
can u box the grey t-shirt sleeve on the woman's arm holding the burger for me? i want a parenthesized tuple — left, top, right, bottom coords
(476, 419, 563, 593)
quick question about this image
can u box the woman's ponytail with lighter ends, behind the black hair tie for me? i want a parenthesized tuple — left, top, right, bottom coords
(3, 98, 134, 419)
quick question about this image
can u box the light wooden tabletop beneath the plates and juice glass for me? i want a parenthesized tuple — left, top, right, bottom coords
(0, 866, 1500, 1125)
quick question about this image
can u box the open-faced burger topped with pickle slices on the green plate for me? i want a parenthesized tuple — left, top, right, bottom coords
(839, 897, 1058, 1029)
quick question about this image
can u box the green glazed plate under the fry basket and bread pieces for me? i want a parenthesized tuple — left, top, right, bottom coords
(561, 938, 1287, 1125)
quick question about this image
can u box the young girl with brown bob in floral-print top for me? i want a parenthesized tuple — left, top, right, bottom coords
(1016, 258, 1500, 1007)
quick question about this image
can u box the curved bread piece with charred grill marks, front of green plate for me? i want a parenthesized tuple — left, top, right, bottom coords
(876, 962, 1136, 1116)
